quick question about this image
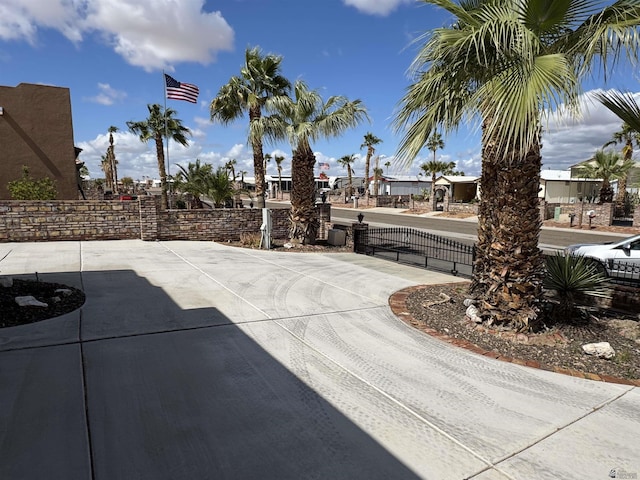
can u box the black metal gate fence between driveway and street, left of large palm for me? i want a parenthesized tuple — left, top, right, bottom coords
(353, 227, 476, 277)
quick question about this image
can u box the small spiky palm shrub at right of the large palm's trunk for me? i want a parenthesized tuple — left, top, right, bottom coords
(543, 252, 611, 323)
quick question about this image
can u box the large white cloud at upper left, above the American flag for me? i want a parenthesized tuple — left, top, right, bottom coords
(0, 0, 234, 71)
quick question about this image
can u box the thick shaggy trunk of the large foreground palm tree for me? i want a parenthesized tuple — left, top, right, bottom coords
(471, 125, 544, 330)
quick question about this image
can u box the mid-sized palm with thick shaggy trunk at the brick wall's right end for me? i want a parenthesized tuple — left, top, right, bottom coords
(255, 80, 368, 244)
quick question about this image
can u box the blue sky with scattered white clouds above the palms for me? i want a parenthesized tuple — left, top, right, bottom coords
(0, 0, 640, 180)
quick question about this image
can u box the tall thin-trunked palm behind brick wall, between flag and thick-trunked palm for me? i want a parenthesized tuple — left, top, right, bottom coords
(210, 47, 291, 208)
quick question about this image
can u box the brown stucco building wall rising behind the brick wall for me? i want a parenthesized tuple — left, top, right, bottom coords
(0, 83, 78, 200)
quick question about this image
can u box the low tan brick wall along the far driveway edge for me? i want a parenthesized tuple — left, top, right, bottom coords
(0, 196, 289, 242)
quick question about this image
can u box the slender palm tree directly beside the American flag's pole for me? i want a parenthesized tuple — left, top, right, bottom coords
(127, 103, 191, 209)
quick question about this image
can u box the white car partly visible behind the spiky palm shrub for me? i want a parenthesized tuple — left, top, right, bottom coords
(565, 235, 640, 280)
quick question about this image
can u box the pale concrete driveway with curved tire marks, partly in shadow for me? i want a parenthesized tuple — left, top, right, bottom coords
(0, 241, 640, 480)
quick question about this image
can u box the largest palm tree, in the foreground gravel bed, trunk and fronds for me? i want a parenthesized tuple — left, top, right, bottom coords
(394, 0, 640, 330)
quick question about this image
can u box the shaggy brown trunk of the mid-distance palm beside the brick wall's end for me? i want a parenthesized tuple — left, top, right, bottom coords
(289, 145, 319, 245)
